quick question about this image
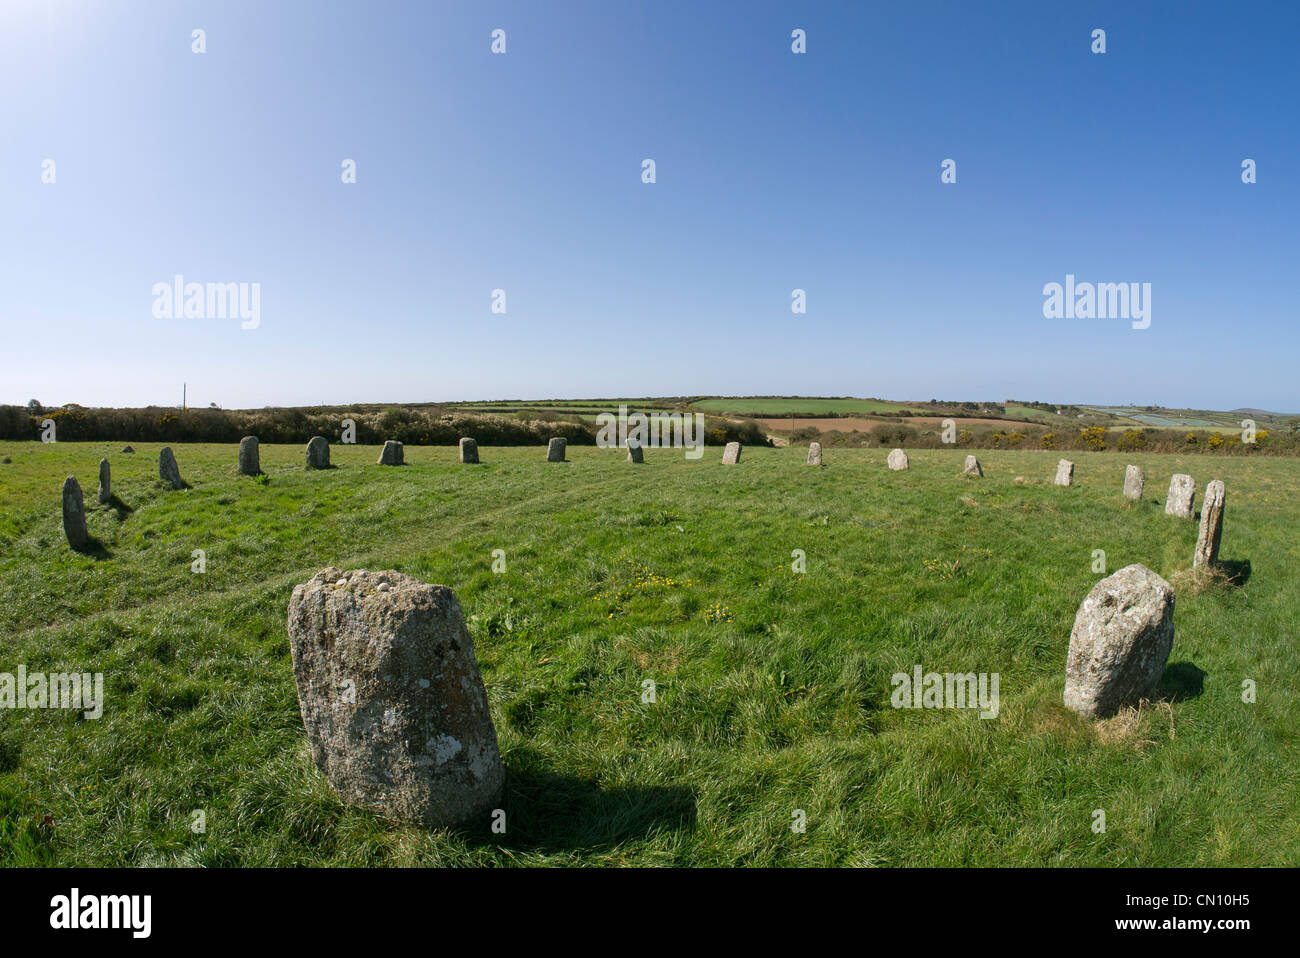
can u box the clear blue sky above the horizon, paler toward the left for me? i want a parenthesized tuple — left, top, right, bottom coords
(0, 0, 1300, 411)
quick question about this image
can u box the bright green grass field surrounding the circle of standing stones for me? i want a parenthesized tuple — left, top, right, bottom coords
(0, 443, 1300, 866)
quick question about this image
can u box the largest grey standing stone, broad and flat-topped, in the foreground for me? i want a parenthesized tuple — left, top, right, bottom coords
(289, 568, 506, 828)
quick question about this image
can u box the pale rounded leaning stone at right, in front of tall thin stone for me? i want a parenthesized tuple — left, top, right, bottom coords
(1065, 564, 1174, 719)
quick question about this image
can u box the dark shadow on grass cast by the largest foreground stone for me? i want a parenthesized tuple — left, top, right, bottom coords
(476, 753, 696, 851)
